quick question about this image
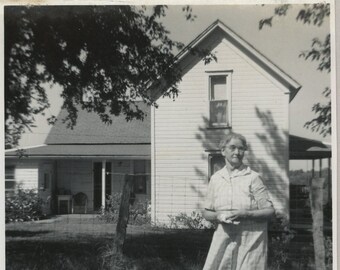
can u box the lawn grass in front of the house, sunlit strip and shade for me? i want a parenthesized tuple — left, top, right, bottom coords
(6, 216, 322, 270)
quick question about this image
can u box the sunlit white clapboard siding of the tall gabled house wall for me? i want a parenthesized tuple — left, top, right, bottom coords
(152, 30, 289, 223)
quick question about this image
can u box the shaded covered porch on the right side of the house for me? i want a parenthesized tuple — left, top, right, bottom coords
(289, 135, 332, 230)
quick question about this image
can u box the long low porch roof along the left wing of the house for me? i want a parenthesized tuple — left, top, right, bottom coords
(5, 144, 151, 159)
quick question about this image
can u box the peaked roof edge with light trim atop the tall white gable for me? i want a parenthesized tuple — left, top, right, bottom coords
(176, 20, 301, 101)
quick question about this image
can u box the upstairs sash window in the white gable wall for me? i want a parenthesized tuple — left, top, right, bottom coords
(209, 74, 231, 127)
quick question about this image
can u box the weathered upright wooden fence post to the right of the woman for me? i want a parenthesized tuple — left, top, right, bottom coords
(310, 178, 326, 270)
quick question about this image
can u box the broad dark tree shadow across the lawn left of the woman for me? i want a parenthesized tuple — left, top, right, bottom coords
(6, 230, 212, 270)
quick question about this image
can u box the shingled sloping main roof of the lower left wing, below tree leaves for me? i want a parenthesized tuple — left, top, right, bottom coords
(45, 102, 151, 145)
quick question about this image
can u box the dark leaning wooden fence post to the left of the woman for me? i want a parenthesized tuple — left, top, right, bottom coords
(114, 174, 133, 254)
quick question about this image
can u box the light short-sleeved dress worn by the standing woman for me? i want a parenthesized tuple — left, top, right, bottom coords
(203, 165, 272, 270)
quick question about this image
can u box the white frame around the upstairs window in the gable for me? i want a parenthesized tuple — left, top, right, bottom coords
(206, 70, 233, 129)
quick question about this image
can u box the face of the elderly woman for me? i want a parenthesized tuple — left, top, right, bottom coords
(221, 138, 246, 168)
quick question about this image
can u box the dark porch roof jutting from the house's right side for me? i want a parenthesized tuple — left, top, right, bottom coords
(289, 135, 332, 160)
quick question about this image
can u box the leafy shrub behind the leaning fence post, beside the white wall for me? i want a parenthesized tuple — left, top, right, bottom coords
(98, 193, 151, 225)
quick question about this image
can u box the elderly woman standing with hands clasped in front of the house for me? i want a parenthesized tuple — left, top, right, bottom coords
(202, 133, 274, 270)
